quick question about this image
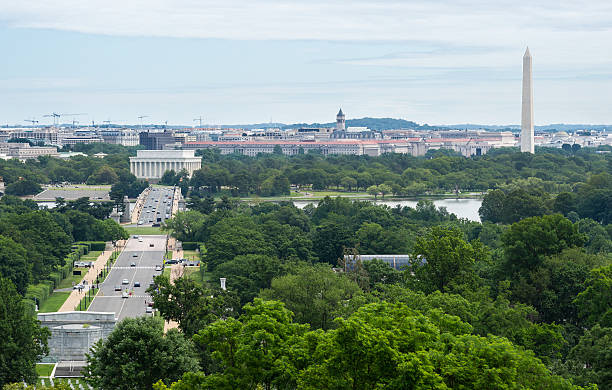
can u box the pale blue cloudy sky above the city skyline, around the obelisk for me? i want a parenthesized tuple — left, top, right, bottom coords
(0, 0, 612, 125)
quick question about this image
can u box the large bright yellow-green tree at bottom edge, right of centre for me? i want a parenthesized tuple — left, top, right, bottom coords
(298, 303, 577, 390)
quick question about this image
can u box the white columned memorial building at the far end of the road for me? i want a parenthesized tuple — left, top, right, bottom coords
(130, 150, 202, 180)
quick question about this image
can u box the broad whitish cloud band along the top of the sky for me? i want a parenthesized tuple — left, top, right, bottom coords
(0, 0, 612, 44)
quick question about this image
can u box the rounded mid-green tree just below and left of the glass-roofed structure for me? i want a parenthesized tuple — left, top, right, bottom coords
(260, 264, 361, 329)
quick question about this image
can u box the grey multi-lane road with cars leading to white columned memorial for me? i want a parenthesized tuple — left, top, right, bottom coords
(88, 187, 174, 320)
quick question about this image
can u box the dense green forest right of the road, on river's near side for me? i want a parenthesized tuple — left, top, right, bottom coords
(79, 184, 612, 390)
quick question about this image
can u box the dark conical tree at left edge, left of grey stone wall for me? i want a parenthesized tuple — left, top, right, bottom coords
(0, 277, 49, 386)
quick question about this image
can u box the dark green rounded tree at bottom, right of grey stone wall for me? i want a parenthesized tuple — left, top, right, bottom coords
(84, 317, 198, 390)
